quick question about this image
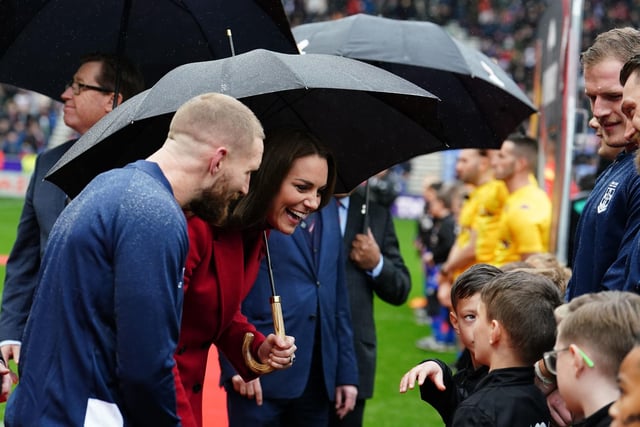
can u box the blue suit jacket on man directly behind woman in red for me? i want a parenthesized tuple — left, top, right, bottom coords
(221, 201, 358, 402)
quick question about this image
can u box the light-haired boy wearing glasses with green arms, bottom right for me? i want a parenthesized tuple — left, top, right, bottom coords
(544, 291, 640, 427)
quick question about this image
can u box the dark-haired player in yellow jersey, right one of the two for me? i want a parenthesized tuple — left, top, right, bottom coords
(492, 134, 551, 266)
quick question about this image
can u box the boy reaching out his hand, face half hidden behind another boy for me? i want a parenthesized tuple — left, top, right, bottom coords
(400, 264, 502, 425)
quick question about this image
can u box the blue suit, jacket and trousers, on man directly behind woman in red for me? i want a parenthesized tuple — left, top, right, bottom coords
(221, 200, 358, 426)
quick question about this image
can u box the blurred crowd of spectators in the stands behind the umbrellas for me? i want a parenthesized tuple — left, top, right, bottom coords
(0, 0, 640, 170)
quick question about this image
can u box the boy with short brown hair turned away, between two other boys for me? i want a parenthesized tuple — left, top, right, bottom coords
(451, 271, 562, 427)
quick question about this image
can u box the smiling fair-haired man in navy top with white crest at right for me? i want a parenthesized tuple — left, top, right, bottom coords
(566, 27, 640, 301)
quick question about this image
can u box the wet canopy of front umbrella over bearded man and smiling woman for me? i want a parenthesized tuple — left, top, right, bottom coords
(47, 49, 445, 197)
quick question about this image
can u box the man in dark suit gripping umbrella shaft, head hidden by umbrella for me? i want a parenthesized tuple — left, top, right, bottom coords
(330, 187, 411, 427)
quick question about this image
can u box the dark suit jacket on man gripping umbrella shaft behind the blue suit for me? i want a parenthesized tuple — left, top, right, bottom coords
(344, 191, 411, 399)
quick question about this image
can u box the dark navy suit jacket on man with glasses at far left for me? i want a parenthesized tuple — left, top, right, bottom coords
(0, 140, 75, 341)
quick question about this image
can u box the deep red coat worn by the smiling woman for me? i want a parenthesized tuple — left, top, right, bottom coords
(174, 216, 264, 426)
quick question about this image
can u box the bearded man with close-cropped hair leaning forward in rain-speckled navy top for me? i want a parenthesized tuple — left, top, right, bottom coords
(5, 94, 294, 426)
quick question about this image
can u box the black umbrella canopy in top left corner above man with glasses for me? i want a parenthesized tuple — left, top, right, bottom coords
(0, 0, 298, 98)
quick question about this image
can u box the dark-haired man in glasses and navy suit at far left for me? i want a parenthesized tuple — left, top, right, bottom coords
(0, 54, 144, 363)
